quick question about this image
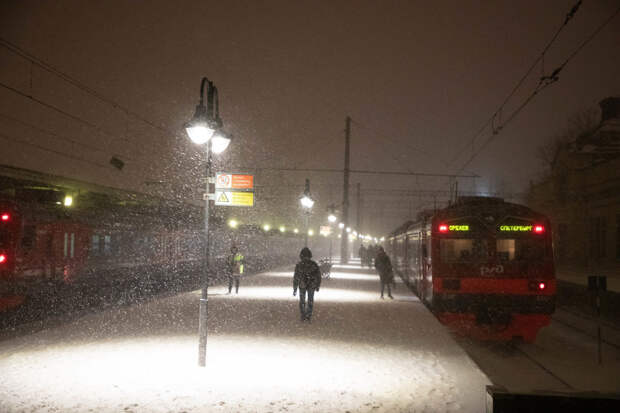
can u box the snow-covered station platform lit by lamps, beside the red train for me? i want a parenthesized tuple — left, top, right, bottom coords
(0, 265, 490, 412)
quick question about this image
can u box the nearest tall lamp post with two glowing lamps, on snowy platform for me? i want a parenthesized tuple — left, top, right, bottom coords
(185, 77, 230, 367)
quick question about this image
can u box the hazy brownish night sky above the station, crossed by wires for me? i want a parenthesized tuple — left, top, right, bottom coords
(0, 0, 620, 235)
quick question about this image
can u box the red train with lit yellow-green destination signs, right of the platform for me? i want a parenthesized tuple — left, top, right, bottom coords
(386, 197, 556, 342)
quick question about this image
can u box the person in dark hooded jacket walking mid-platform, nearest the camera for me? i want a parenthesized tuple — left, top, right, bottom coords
(293, 247, 321, 322)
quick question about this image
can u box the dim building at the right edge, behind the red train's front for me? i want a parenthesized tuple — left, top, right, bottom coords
(528, 97, 620, 277)
